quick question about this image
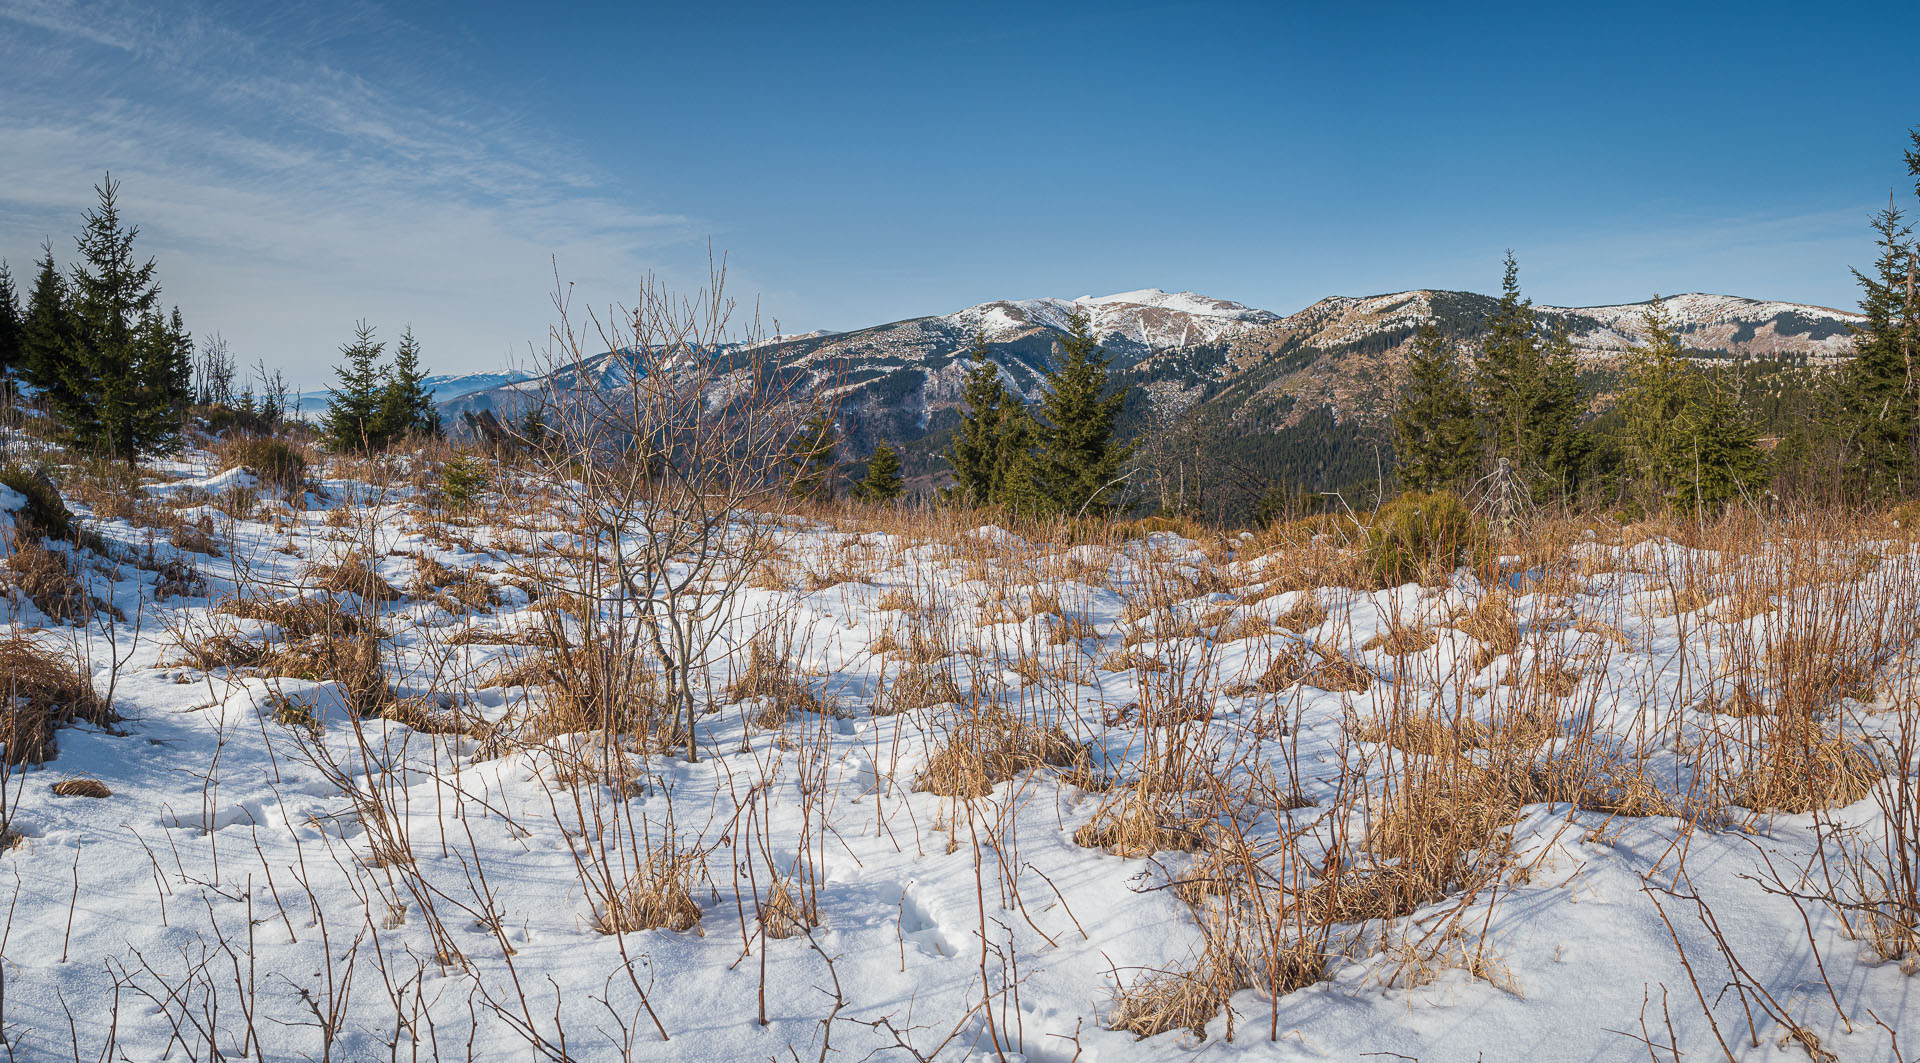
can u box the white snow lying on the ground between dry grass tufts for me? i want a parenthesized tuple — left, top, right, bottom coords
(0, 448, 1920, 1063)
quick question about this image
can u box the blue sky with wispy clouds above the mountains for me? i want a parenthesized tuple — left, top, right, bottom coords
(0, 0, 1920, 386)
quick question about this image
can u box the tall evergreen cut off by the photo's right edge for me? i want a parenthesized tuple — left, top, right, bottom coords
(1832, 203, 1920, 497)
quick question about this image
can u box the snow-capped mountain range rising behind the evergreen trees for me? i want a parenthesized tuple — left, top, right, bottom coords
(442, 288, 1860, 510)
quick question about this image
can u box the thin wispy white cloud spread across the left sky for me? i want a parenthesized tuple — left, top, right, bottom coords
(0, 0, 695, 379)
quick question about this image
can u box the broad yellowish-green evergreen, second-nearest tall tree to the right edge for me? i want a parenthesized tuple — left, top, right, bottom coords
(1620, 297, 1768, 514)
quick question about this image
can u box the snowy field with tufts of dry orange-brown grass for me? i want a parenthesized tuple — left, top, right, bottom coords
(0, 443, 1920, 1063)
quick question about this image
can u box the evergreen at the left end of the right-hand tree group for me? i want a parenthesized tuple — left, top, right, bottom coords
(1394, 320, 1480, 491)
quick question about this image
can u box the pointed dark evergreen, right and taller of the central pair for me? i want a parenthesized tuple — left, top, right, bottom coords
(1016, 311, 1133, 516)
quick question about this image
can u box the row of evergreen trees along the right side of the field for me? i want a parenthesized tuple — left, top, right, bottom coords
(1394, 129, 1920, 514)
